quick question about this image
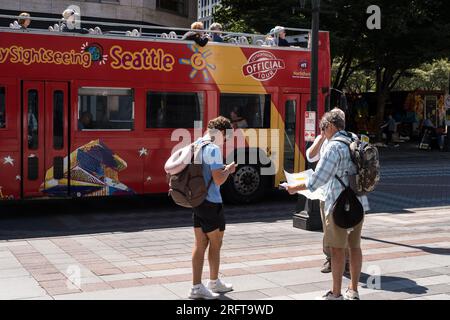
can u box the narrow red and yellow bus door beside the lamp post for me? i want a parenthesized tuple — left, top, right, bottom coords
(282, 94, 309, 173)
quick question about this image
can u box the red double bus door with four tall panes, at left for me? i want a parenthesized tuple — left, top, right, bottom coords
(22, 81, 69, 198)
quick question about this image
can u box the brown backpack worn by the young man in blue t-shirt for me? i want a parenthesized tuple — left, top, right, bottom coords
(167, 141, 213, 208)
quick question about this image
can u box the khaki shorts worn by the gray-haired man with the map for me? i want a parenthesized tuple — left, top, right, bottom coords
(325, 213, 364, 249)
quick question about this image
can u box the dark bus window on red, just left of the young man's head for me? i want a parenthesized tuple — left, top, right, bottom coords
(147, 92, 203, 129)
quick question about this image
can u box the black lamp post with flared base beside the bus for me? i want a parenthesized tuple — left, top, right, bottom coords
(293, 0, 322, 230)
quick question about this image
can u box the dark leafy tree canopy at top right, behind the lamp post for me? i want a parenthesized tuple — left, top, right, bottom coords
(216, 0, 450, 127)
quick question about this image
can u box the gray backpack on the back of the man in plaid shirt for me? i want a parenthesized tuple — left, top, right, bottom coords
(333, 133, 380, 196)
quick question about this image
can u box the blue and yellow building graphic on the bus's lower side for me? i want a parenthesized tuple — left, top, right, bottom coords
(40, 140, 135, 197)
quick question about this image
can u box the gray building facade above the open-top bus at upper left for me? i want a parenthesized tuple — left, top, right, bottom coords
(0, 0, 197, 28)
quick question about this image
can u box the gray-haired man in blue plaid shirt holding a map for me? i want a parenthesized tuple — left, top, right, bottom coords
(287, 110, 369, 300)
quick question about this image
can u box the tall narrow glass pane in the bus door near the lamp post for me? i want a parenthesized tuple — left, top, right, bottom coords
(284, 100, 297, 172)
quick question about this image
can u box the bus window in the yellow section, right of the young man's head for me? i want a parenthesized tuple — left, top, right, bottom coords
(220, 93, 271, 128)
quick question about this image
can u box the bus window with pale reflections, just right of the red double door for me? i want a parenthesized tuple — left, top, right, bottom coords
(78, 87, 134, 131)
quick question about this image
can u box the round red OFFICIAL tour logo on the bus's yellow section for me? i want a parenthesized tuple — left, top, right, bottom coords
(242, 51, 285, 81)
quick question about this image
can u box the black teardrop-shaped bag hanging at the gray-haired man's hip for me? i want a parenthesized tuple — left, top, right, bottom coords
(331, 175, 364, 229)
